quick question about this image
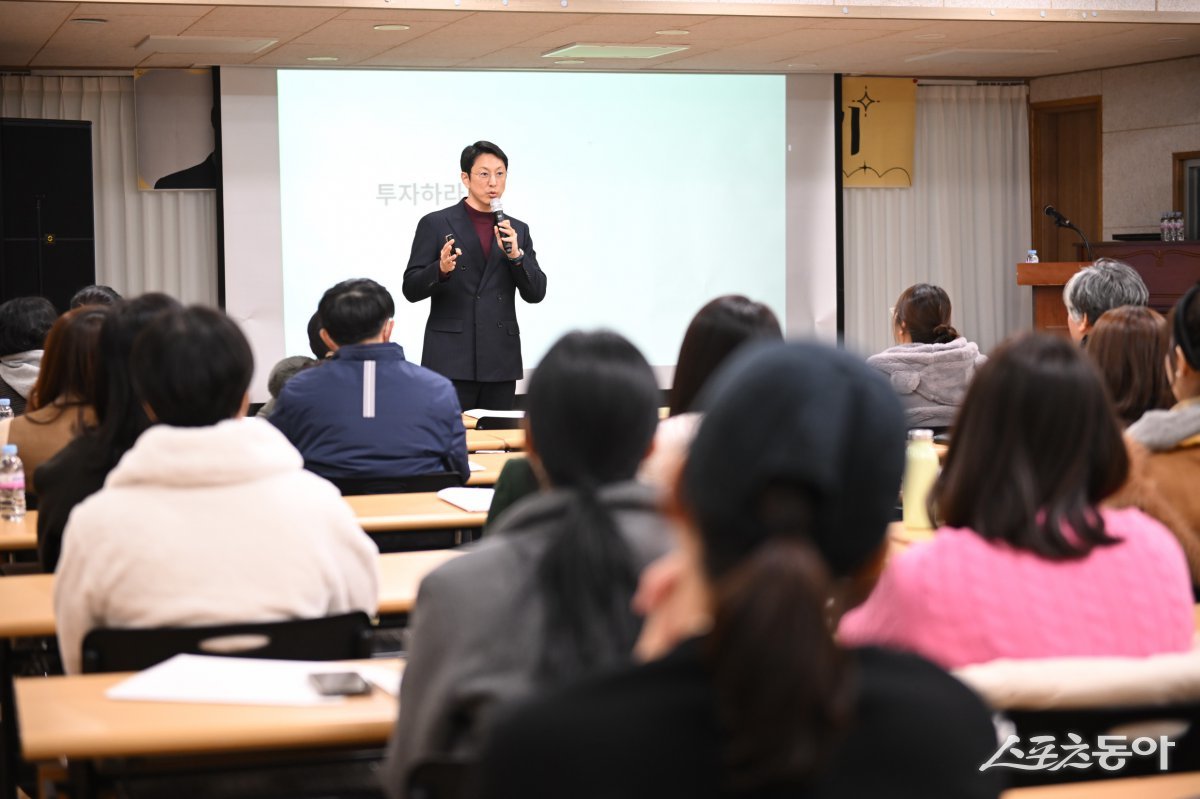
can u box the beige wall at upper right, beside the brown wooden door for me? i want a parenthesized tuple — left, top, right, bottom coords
(1030, 58, 1200, 239)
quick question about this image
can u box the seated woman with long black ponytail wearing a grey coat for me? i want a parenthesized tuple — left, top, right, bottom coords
(388, 328, 670, 797)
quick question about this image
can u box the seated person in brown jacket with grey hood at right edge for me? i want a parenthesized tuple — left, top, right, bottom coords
(1108, 286, 1200, 585)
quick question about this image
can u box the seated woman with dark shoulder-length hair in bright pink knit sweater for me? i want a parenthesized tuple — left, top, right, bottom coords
(840, 334, 1194, 668)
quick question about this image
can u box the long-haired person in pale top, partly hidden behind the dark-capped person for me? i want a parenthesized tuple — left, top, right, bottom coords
(637, 294, 784, 489)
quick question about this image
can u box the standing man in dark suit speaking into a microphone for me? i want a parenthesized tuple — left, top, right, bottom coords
(404, 142, 546, 410)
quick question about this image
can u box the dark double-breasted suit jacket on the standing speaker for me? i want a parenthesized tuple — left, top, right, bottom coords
(404, 200, 546, 383)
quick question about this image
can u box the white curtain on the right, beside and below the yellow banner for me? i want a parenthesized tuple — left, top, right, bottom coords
(842, 86, 1032, 354)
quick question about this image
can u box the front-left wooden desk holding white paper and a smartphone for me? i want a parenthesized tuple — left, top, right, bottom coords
(16, 660, 403, 761)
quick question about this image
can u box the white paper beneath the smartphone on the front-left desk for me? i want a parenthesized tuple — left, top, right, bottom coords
(106, 655, 381, 707)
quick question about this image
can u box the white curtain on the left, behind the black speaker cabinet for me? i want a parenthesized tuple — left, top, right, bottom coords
(0, 76, 217, 305)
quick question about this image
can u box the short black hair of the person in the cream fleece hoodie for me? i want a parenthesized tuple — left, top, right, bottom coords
(130, 305, 254, 427)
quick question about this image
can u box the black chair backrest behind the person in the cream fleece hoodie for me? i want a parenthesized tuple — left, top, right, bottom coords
(83, 611, 371, 673)
